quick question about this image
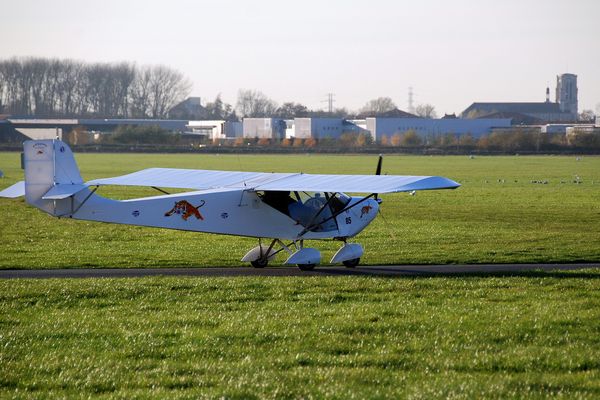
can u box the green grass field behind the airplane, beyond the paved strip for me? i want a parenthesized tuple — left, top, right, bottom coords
(0, 153, 600, 268)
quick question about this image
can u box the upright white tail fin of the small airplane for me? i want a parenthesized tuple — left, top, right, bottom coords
(23, 139, 86, 216)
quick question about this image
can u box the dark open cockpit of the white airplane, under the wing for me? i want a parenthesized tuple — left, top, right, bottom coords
(257, 191, 350, 232)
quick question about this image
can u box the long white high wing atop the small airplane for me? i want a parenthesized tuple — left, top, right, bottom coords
(86, 168, 460, 193)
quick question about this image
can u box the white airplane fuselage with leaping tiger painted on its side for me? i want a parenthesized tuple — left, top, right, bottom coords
(64, 189, 379, 240)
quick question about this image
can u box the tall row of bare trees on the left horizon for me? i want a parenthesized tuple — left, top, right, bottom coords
(0, 57, 191, 118)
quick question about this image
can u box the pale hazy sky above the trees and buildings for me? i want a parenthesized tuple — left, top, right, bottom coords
(0, 0, 600, 115)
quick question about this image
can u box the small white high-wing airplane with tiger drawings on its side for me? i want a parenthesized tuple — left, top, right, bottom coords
(0, 140, 460, 270)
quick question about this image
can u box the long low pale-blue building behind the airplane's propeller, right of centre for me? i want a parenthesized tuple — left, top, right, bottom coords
(367, 118, 511, 140)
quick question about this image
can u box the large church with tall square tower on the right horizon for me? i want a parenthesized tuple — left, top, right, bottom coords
(461, 74, 577, 123)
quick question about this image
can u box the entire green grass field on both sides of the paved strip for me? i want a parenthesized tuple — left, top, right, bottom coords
(0, 153, 600, 399)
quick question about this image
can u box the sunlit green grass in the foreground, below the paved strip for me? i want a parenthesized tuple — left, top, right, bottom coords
(0, 270, 600, 399)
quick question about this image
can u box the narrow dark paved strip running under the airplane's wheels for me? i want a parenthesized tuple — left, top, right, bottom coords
(0, 264, 600, 279)
